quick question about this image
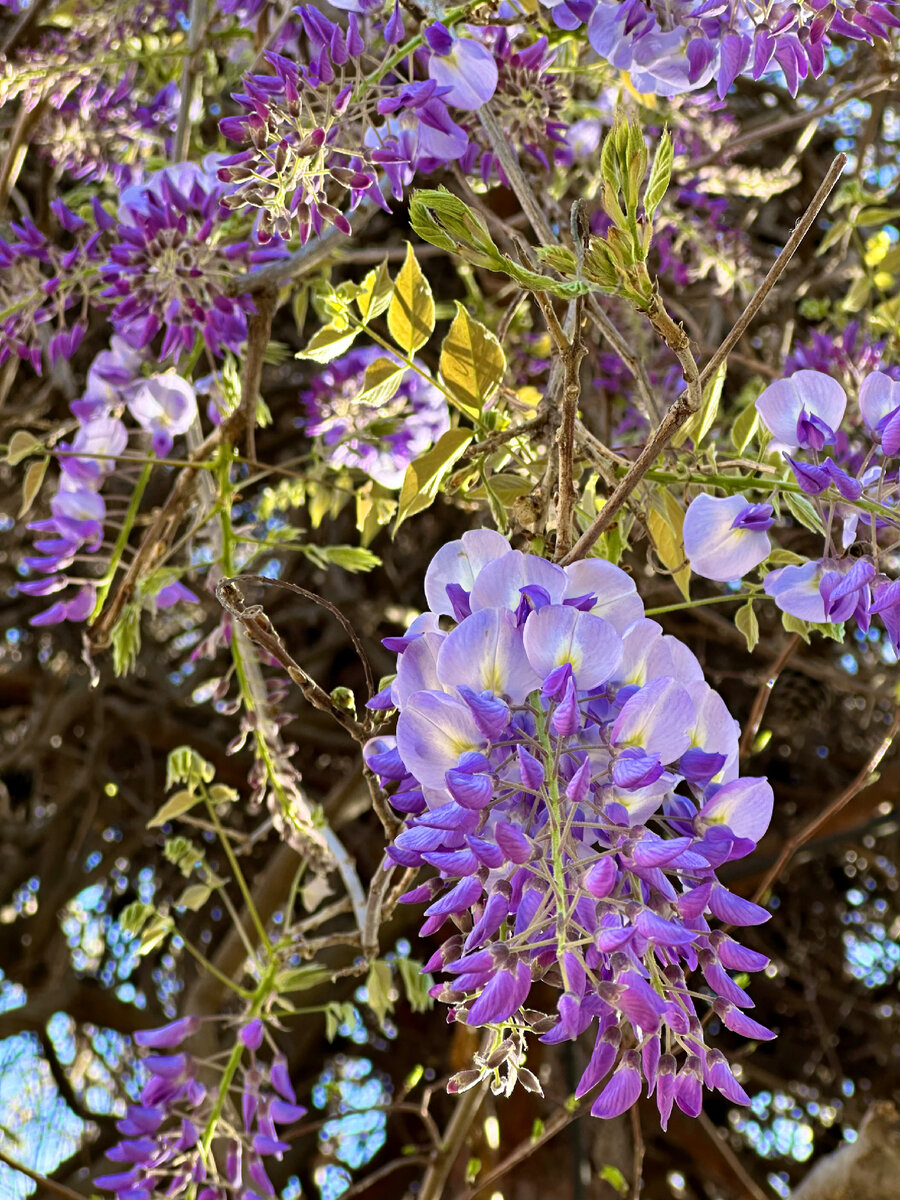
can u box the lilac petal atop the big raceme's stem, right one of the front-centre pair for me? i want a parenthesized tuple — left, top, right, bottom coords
(523, 605, 622, 691)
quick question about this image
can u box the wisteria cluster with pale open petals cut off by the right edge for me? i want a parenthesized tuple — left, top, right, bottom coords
(684, 370, 900, 653)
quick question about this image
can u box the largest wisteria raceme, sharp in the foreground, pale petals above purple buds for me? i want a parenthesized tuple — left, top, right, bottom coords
(366, 529, 773, 1124)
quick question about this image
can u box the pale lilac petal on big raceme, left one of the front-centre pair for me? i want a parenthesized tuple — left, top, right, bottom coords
(439, 609, 540, 704)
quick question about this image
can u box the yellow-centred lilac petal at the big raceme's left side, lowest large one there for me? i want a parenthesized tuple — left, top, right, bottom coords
(397, 691, 487, 787)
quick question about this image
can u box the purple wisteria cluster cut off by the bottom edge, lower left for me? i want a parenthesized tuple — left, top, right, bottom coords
(94, 1016, 306, 1200)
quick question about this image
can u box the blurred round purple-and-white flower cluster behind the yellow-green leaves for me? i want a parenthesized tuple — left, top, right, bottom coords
(301, 347, 450, 487)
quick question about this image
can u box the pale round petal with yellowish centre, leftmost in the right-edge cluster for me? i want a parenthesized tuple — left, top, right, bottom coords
(683, 493, 772, 583)
